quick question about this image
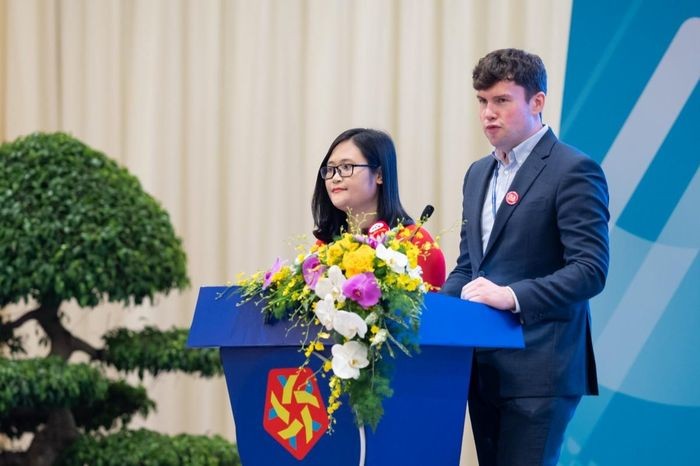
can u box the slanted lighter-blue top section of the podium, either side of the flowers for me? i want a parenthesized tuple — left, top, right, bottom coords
(187, 286, 524, 348)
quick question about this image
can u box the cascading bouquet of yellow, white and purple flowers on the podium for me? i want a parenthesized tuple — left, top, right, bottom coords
(238, 223, 434, 429)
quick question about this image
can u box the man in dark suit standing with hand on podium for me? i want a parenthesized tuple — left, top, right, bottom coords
(442, 49, 609, 466)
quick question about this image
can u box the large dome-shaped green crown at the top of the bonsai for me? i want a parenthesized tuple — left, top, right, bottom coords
(0, 133, 188, 307)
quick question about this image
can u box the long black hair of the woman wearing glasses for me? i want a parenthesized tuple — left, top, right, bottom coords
(311, 128, 413, 243)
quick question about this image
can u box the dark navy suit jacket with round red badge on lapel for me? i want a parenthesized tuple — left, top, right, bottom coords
(442, 130, 609, 397)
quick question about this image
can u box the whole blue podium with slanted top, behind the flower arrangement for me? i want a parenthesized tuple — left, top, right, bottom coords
(187, 287, 524, 466)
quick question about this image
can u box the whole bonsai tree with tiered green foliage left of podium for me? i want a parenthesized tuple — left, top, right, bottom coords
(0, 133, 239, 466)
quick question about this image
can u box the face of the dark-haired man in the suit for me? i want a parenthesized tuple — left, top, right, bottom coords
(476, 81, 545, 153)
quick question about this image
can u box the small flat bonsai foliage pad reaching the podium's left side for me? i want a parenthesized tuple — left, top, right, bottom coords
(102, 327, 222, 377)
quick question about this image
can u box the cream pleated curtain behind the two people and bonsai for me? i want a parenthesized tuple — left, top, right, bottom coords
(0, 0, 571, 464)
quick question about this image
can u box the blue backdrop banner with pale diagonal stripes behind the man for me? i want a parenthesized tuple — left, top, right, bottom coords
(560, 0, 700, 466)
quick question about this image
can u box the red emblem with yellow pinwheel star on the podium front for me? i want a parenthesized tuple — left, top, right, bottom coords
(263, 367, 328, 460)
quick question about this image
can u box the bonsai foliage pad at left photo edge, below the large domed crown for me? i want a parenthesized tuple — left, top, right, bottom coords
(0, 357, 109, 436)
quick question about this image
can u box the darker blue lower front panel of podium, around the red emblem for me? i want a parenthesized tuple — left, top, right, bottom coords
(221, 347, 472, 466)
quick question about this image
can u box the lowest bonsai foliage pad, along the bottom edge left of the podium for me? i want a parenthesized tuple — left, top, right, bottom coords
(56, 429, 241, 466)
